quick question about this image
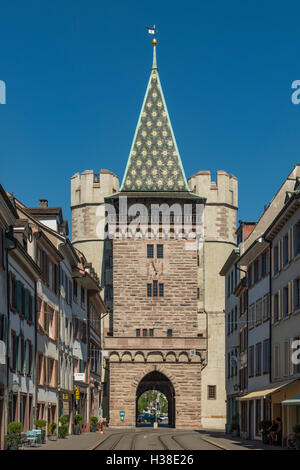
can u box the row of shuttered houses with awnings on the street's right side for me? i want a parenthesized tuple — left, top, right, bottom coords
(223, 165, 300, 445)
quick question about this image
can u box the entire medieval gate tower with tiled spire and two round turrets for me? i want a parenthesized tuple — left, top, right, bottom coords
(71, 43, 237, 429)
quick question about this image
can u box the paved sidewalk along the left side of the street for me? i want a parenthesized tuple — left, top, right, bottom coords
(24, 430, 112, 450)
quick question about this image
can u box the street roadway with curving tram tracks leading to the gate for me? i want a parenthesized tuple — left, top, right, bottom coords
(95, 428, 220, 451)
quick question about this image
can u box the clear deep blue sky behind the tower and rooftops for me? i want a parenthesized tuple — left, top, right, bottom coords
(0, 0, 300, 232)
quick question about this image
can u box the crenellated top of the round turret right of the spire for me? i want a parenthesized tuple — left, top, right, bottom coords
(188, 170, 238, 207)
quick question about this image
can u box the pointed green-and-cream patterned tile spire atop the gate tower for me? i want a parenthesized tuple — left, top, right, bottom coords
(121, 39, 189, 192)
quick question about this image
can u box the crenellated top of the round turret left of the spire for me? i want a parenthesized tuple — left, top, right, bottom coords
(71, 169, 120, 208)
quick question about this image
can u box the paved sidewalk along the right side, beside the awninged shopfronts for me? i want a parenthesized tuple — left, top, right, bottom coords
(199, 431, 285, 450)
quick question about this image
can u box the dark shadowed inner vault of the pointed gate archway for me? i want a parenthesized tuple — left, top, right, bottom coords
(136, 370, 175, 427)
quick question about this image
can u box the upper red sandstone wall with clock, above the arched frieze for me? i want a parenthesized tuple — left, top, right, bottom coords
(113, 239, 198, 337)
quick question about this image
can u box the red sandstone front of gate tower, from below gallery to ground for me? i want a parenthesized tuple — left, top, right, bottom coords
(106, 239, 205, 428)
